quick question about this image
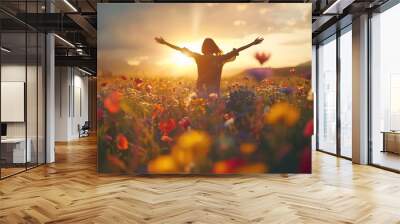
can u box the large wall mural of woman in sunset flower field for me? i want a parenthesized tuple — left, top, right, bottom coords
(97, 3, 313, 174)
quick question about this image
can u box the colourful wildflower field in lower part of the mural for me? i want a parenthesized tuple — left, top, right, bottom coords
(97, 65, 313, 174)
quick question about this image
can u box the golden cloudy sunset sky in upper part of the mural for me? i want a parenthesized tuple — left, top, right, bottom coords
(98, 3, 311, 76)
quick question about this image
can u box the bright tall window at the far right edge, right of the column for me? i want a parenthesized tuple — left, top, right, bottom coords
(370, 4, 400, 170)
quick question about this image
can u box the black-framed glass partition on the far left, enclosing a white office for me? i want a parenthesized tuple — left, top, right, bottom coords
(0, 1, 46, 179)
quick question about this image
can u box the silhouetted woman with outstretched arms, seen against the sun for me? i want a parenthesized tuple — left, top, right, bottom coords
(155, 37, 264, 97)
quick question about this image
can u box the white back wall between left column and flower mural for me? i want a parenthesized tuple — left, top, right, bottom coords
(55, 67, 88, 141)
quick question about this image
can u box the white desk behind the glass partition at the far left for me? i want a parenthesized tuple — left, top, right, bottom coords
(1, 138, 32, 163)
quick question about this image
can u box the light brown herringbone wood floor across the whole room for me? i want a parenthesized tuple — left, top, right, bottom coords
(0, 138, 400, 224)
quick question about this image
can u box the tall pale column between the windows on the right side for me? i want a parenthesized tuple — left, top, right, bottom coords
(352, 15, 368, 164)
